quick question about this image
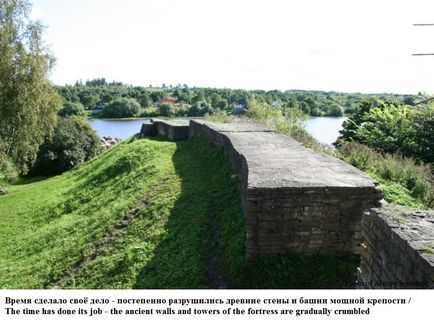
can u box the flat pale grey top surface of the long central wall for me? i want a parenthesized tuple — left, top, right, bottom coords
(192, 120, 376, 190)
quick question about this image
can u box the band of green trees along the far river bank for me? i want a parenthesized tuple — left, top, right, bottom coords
(57, 78, 424, 118)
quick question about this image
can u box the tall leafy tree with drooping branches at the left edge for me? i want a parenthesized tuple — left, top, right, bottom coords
(0, 0, 61, 174)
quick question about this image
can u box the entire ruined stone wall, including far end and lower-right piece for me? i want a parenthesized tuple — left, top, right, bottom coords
(141, 120, 434, 288)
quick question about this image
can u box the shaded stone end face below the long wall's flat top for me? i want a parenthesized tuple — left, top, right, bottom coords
(245, 187, 378, 256)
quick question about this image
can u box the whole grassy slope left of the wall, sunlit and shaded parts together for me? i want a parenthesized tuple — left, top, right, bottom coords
(0, 138, 358, 289)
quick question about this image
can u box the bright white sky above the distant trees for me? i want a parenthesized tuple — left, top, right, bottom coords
(32, 0, 434, 94)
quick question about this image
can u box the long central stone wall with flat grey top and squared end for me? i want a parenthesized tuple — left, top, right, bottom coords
(190, 121, 382, 259)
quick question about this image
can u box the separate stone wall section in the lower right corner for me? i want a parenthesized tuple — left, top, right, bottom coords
(359, 204, 434, 289)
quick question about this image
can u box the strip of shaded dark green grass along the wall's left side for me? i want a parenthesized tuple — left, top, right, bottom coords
(134, 139, 213, 288)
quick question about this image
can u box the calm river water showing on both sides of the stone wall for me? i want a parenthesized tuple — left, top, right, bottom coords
(89, 117, 346, 145)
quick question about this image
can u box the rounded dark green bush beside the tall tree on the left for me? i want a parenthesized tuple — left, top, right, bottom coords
(30, 117, 101, 176)
